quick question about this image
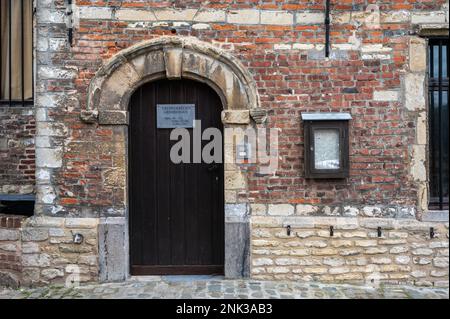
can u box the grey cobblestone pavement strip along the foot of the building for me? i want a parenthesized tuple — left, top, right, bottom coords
(0, 276, 449, 299)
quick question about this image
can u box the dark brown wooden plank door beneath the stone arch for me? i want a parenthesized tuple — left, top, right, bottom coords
(129, 80, 224, 275)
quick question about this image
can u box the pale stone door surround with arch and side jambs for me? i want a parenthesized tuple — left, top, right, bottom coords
(81, 37, 265, 281)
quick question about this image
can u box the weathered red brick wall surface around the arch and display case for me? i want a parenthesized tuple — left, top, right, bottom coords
(30, 0, 445, 213)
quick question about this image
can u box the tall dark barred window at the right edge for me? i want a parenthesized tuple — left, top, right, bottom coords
(428, 38, 449, 210)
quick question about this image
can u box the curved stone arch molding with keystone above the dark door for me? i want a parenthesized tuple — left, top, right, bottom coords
(81, 37, 266, 125)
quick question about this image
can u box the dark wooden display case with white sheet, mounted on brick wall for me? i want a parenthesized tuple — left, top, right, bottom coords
(302, 113, 352, 178)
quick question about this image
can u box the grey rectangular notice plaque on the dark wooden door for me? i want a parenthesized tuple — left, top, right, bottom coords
(156, 104, 195, 128)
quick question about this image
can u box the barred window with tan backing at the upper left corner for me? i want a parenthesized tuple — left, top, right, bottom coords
(0, 0, 34, 106)
